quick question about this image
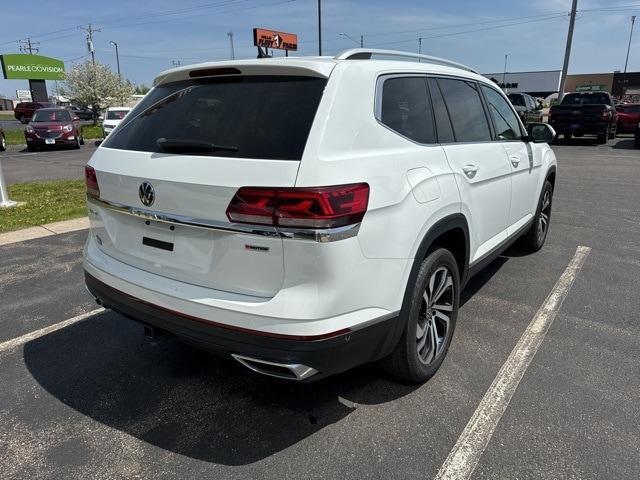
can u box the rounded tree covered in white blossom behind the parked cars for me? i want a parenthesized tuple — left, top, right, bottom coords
(61, 60, 134, 121)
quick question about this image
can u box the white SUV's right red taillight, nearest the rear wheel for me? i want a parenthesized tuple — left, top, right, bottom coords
(227, 183, 369, 228)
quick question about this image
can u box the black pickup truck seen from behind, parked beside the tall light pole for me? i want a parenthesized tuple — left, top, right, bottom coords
(549, 92, 618, 143)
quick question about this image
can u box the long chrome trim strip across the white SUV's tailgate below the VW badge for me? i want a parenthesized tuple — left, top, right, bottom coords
(87, 196, 360, 243)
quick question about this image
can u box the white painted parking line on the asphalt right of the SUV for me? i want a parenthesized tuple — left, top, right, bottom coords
(436, 247, 591, 480)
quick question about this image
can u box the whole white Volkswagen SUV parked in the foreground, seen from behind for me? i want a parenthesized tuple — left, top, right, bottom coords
(84, 49, 556, 382)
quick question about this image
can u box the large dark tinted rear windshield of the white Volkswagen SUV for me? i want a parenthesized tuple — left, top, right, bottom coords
(103, 76, 326, 160)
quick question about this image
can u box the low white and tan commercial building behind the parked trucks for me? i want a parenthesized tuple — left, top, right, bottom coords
(483, 70, 640, 98)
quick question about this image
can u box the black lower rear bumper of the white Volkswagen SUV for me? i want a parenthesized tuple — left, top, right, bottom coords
(85, 271, 398, 381)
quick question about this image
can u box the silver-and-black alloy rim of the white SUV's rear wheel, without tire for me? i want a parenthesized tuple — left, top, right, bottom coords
(416, 267, 455, 365)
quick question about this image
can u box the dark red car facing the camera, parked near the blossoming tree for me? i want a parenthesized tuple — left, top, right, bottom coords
(24, 108, 84, 152)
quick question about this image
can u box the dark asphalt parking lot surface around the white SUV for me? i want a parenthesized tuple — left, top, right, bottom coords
(0, 138, 640, 479)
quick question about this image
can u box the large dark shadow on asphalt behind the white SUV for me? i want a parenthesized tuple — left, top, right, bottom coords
(24, 312, 417, 465)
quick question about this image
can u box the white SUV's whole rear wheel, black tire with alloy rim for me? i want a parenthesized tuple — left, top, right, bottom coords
(384, 248, 460, 383)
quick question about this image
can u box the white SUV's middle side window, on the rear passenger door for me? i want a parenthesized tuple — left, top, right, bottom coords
(438, 78, 491, 142)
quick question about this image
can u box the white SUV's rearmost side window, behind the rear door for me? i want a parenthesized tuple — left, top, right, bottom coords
(379, 77, 436, 143)
